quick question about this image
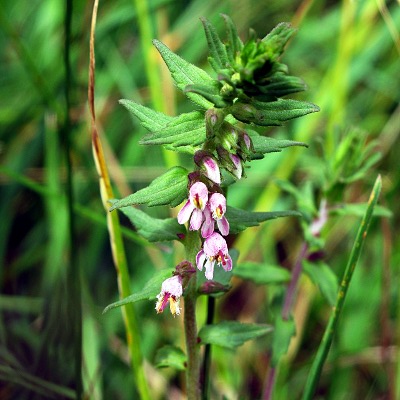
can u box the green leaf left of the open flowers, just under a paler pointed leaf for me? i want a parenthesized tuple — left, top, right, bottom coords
(113, 205, 186, 242)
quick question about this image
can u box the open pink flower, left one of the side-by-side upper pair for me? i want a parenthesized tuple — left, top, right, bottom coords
(178, 182, 208, 231)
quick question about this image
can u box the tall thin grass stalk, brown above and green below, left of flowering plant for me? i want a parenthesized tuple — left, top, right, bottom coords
(88, 0, 151, 400)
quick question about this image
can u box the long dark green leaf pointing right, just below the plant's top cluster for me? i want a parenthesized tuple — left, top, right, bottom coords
(230, 99, 319, 126)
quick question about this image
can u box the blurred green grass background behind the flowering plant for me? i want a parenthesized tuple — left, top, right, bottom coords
(0, 0, 400, 400)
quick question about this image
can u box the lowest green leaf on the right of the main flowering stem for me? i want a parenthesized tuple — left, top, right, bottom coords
(199, 321, 273, 349)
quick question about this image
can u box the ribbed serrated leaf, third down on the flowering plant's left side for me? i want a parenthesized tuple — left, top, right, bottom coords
(140, 111, 206, 148)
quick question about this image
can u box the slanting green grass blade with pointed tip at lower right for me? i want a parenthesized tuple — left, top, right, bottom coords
(303, 175, 382, 400)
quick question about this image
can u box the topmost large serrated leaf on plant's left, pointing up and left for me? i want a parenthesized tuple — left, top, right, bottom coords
(153, 40, 213, 109)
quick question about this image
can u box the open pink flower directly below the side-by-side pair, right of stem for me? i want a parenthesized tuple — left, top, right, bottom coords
(196, 232, 232, 280)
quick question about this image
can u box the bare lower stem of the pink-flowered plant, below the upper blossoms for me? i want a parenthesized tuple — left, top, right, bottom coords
(184, 231, 201, 400)
